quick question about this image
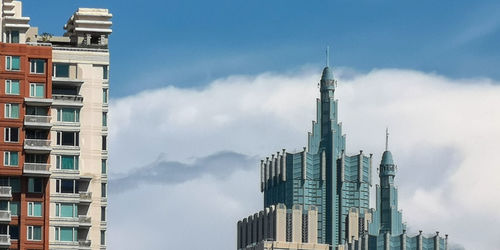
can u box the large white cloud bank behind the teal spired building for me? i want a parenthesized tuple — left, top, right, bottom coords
(110, 69, 500, 249)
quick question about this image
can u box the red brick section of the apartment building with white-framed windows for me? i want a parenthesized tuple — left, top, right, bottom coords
(0, 43, 52, 250)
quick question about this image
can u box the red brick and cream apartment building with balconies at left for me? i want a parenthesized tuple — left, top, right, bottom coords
(0, 0, 112, 249)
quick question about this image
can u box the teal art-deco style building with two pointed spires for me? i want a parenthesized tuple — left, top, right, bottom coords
(237, 58, 448, 250)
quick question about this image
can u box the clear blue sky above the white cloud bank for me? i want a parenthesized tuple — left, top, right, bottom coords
(24, 0, 500, 97)
